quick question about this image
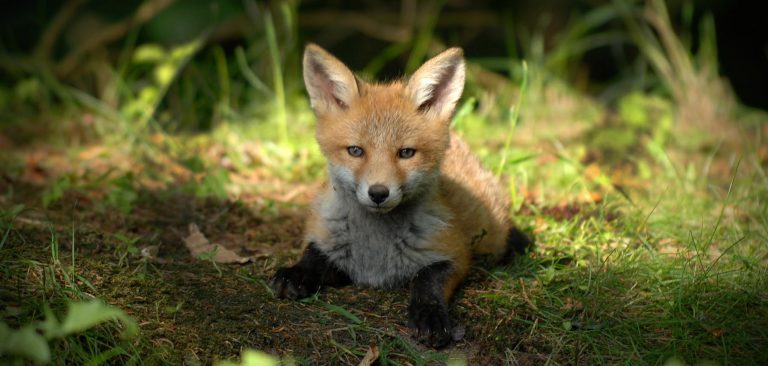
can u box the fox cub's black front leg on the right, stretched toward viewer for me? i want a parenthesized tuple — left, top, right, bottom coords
(408, 261, 456, 348)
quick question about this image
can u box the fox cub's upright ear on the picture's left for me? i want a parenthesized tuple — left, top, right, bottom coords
(304, 43, 359, 114)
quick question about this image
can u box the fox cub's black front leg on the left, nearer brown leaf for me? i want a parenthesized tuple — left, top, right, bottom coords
(270, 243, 352, 300)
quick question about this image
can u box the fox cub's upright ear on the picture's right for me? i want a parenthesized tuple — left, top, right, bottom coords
(406, 47, 464, 119)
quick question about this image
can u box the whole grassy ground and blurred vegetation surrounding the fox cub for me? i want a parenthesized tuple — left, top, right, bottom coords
(0, 0, 768, 365)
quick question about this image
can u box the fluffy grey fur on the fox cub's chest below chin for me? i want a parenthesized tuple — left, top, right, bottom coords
(310, 194, 449, 287)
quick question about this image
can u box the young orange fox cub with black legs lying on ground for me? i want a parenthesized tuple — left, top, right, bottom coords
(271, 44, 520, 348)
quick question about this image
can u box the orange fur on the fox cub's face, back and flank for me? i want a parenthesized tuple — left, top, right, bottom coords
(305, 45, 511, 299)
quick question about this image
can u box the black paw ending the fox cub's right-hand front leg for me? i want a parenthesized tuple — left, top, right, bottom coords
(408, 302, 453, 349)
